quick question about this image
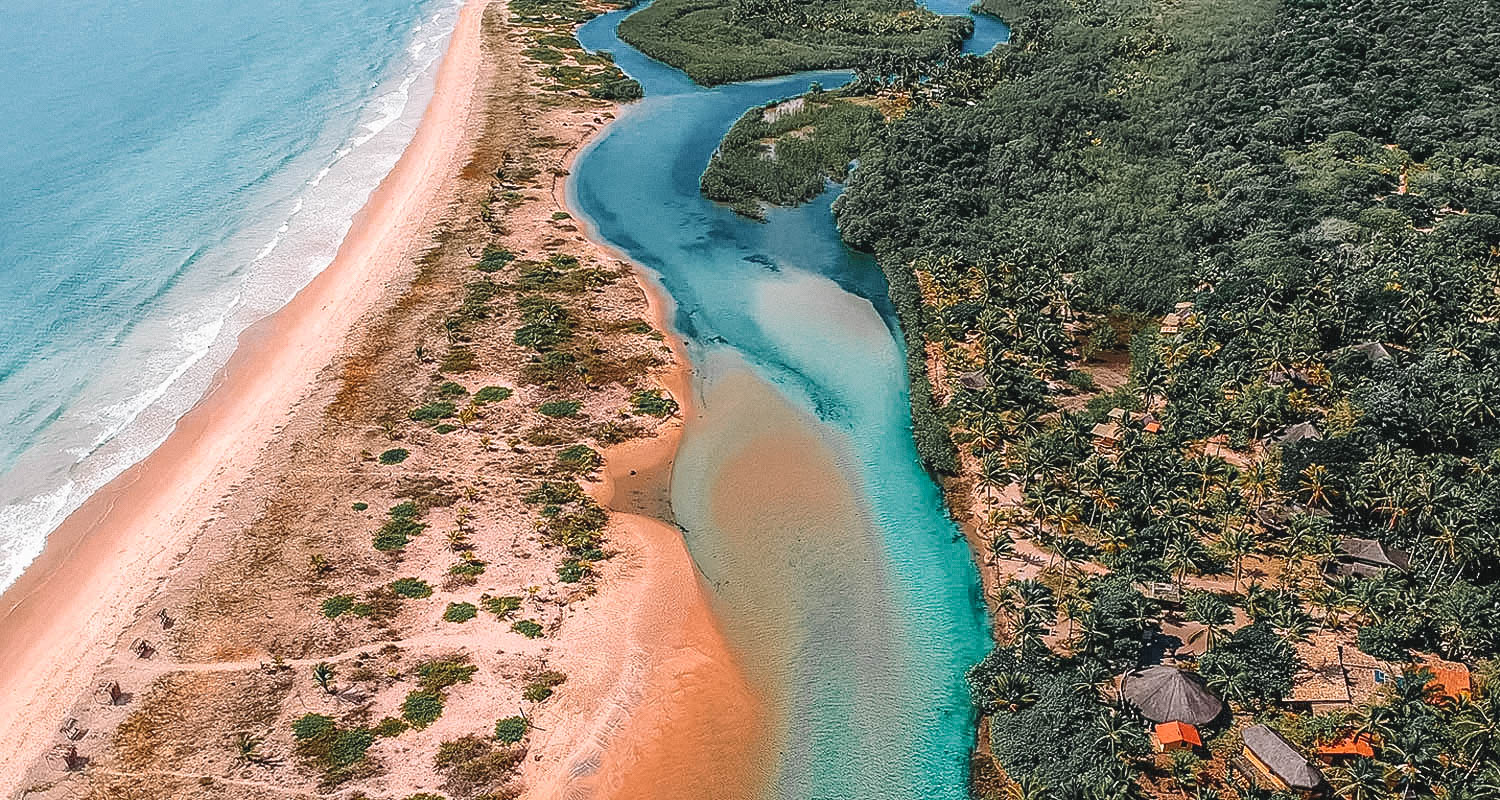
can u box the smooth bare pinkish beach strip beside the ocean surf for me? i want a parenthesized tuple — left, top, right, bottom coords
(0, 0, 488, 786)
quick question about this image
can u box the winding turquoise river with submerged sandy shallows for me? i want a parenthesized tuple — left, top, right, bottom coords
(569, 9, 1004, 800)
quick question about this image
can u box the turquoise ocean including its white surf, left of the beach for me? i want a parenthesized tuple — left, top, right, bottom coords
(0, 0, 459, 587)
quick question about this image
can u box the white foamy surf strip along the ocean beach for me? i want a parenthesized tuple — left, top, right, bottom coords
(0, 0, 462, 588)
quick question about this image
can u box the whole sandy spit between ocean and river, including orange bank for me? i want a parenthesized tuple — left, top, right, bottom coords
(0, 0, 750, 800)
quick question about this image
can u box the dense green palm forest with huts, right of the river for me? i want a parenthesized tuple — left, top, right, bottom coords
(684, 0, 1500, 800)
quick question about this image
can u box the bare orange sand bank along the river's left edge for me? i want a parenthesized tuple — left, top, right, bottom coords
(527, 82, 768, 800)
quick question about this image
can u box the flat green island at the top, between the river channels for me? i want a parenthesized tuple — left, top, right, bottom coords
(620, 0, 974, 86)
